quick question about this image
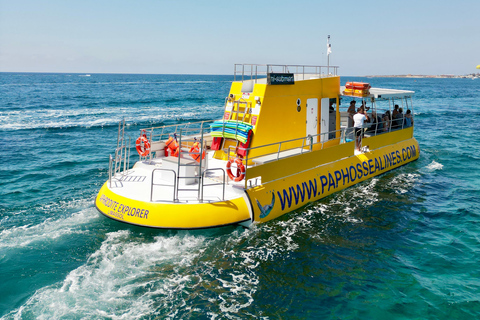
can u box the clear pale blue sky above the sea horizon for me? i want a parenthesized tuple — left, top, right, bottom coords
(0, 0, 480, 75)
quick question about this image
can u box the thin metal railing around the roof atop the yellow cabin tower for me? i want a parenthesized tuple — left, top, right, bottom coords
(233, 63, 338, 81)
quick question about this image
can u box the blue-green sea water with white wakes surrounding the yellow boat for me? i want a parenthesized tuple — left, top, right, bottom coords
(0, 73, 480, 319)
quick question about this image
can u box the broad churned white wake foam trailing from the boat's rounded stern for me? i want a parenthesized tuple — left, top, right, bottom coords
(4, 230, 205, 319)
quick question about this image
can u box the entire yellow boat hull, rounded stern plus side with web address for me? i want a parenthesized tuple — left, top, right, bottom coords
(95, 132, 420, 229)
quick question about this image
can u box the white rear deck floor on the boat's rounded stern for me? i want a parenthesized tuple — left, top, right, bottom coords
(110, 151, 245, 203)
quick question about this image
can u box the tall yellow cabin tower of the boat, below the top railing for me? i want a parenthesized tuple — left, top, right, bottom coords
(216, 76, 340, 159)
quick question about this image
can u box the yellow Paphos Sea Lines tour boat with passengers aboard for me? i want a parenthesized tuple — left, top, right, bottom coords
(95, 64, 420, 229)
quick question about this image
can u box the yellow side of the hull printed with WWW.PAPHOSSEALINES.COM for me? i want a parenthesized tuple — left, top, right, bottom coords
(247, 138, 420, 222)
